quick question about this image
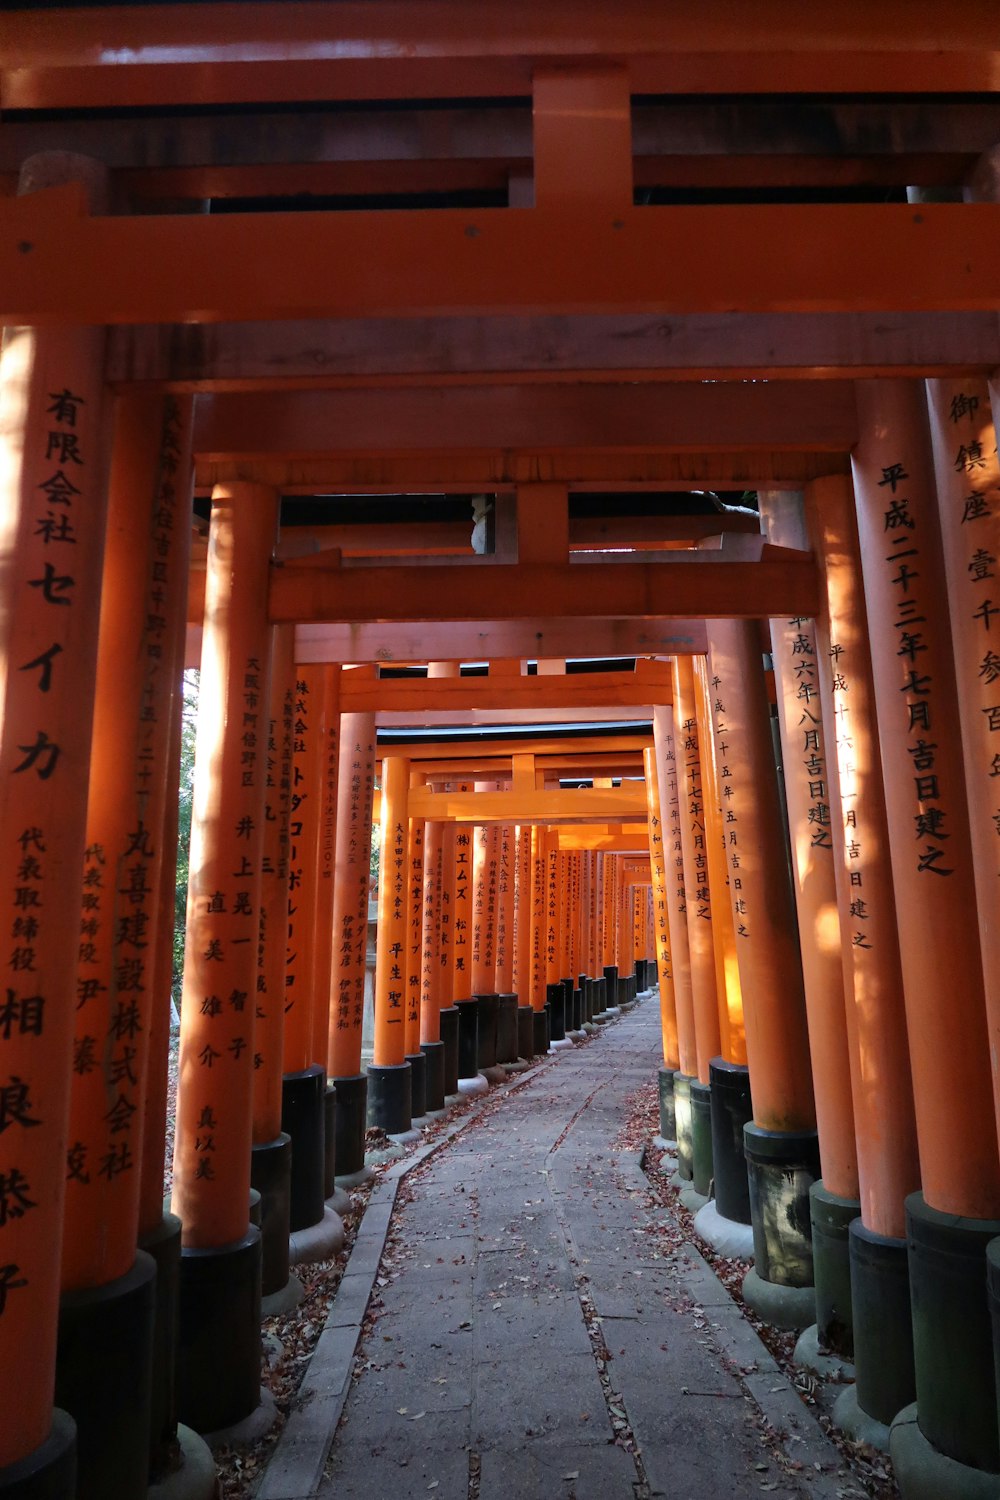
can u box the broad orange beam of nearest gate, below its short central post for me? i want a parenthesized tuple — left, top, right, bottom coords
(0, 186, 1000, 326)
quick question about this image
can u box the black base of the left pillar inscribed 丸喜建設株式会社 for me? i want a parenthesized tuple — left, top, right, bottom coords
(54, 1250, 156, 1500)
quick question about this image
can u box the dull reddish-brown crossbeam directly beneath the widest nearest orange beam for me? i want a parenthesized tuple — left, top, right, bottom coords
(106, 311, 1000, 392)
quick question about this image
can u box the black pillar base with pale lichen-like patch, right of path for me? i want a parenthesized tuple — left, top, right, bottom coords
(744, 1121, 820, 1284)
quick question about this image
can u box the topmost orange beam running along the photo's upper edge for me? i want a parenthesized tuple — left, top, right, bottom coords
(7, 0, 1000, 110)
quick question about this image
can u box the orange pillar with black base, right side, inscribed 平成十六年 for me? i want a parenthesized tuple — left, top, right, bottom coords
(804, 476, 921, 1448)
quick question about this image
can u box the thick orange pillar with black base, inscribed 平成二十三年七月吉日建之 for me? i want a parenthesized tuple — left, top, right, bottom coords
(852, 380, 1000, 1472)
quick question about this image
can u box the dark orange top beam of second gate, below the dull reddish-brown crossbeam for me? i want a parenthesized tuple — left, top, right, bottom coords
(195, 381, 858, 461)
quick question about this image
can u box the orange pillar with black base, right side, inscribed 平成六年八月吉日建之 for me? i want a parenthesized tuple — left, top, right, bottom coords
(759, 491, 863, 1359)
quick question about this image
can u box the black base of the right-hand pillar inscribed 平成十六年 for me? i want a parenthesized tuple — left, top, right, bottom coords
(834, 1218, 916, 1428)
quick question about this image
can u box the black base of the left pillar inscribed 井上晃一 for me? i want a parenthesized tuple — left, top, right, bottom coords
(176, 1224, 261, 1434)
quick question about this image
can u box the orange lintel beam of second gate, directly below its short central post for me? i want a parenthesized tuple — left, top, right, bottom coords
(270, 552, 819, 624)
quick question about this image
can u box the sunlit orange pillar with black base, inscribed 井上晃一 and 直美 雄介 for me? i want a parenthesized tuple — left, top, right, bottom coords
(172, 482, 277, 1431)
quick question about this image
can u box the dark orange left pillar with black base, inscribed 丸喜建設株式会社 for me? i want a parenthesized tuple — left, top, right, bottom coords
(57, 398, 197, 1497)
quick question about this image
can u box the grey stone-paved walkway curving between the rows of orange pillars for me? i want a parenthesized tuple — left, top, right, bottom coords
(263, 1002, 861, 1500)
